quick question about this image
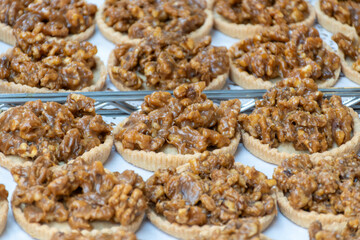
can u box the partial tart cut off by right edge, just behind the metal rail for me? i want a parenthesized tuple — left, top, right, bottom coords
(332, 33, 360, 84)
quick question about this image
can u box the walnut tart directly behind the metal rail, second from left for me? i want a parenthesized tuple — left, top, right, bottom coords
(108, 28, 229, 91)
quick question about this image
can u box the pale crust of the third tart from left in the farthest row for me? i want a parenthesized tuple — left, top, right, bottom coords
(214, 2, 316, 39)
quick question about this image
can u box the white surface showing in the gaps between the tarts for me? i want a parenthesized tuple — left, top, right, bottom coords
(0, 0, 359, 240)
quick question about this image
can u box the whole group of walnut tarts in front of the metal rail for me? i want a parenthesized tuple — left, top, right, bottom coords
(0, 77, 360, 240)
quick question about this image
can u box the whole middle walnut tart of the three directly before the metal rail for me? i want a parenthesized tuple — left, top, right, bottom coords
(114, 83, 241, 171)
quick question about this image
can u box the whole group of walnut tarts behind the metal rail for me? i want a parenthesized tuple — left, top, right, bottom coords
(0, 0, 360, 92)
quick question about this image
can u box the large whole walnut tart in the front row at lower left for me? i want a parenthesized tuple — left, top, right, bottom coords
(11, 158, 147, 240)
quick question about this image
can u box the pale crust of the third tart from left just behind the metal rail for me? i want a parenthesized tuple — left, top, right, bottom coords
(230, 42, 340, 89)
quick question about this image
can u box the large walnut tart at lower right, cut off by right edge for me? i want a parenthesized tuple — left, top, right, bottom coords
(273, 153, 360, 228)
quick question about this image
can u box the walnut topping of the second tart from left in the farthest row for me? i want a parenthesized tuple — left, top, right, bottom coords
(102, 0, 207, 38)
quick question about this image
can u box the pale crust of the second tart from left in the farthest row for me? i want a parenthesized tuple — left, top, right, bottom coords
(95, 4, 213, 44)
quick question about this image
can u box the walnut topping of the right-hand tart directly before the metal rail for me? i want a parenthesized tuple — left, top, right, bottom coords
(239, 78, 353, 153)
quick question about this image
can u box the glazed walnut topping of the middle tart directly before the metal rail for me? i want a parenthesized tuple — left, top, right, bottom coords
(115, 82, 241, 154)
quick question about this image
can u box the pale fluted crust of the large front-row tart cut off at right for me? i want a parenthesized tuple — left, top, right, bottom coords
(276, 190, 350, 228)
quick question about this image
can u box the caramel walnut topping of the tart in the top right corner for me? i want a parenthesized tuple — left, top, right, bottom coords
(320, 0, 360, 35)
